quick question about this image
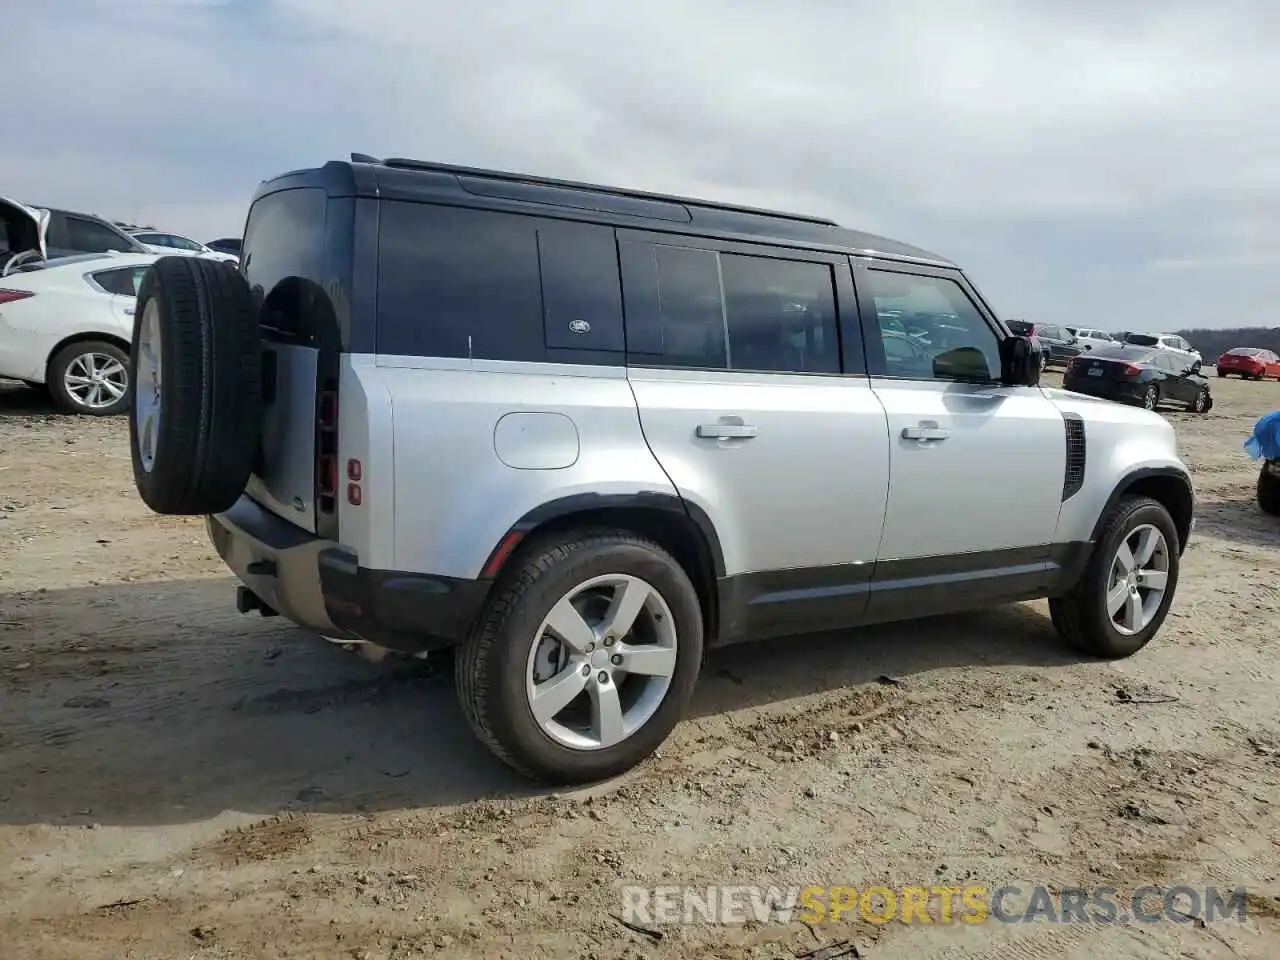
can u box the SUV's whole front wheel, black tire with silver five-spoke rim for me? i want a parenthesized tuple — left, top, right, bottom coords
(1050, 497, 1180, 659)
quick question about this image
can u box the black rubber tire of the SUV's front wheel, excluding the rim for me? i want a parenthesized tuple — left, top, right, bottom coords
(1048, 497, 1180, 659)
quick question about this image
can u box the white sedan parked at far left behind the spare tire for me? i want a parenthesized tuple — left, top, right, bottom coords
(0, 253, 159, 416)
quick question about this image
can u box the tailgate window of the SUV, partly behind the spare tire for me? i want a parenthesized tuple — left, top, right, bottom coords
(242, 187, 326, 335)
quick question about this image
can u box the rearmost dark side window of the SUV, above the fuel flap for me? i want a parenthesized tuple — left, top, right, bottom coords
(378, 202, 625, 362)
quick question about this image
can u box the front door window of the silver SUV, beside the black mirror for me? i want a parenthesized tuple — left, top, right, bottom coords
(864, 270, 1003, 380)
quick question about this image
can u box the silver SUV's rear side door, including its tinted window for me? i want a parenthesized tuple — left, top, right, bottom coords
(618, 230, 888, 636)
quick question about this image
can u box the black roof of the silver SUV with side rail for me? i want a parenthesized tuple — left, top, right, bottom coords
(255, 154, 955, 268)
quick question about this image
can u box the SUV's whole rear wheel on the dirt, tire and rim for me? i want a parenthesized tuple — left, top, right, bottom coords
(454, 530, 703, 785)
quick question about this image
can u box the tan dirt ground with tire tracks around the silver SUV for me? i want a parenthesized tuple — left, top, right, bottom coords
(0, 380, 1280, 960)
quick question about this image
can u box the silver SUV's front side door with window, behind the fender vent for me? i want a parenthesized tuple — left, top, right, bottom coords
(855, 261, 1066, 614)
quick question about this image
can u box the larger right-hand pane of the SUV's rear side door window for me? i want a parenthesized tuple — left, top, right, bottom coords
(721, 253, 840, 374)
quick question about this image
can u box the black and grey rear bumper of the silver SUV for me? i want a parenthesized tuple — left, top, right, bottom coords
(205, 497, 492, 653)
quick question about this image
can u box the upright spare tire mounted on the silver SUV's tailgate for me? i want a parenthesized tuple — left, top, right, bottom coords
(129, 256, 262, 516)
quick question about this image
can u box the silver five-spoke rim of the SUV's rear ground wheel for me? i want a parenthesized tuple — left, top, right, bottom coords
(525, 573, 677, 750)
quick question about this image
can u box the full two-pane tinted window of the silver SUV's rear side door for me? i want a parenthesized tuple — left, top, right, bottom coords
(618, 241, 841, 374)
